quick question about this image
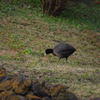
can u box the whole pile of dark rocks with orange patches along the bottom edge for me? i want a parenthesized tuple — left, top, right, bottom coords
(0, 66, 78, 100)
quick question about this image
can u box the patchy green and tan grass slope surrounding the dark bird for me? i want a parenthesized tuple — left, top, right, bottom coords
(0, 2, 100, 100)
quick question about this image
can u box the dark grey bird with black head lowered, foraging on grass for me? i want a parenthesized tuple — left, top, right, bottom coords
(45, 43, 76, 60)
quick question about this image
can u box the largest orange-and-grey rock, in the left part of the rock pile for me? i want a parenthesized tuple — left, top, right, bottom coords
(0, 76, 31, 95)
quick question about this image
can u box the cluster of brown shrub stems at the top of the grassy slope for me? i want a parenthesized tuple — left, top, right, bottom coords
(41, 0, 68, 16)
